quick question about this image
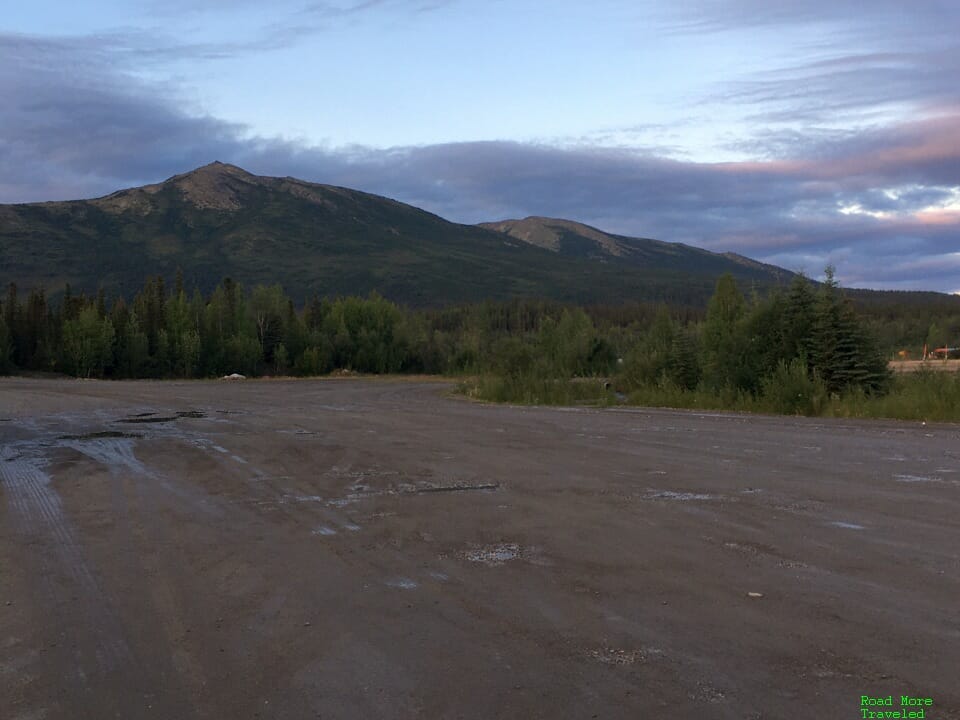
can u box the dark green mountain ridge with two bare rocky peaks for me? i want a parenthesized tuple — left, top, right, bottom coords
(0, 163, 790, 306)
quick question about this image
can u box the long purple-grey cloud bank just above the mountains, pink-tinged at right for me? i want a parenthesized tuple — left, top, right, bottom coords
(0, 27, 960, 291)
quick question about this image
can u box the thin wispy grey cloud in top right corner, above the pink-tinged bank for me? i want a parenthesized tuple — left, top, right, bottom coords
(668, 0, 960, 126)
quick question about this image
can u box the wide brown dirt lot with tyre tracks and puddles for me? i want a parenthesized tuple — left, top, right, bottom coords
(0, 379, 960, 720)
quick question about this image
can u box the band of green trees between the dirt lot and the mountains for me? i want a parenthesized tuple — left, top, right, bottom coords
(0, 270, 889, 393)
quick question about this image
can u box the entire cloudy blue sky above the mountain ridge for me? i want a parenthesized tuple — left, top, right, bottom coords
(0, 0, 960, 292)
